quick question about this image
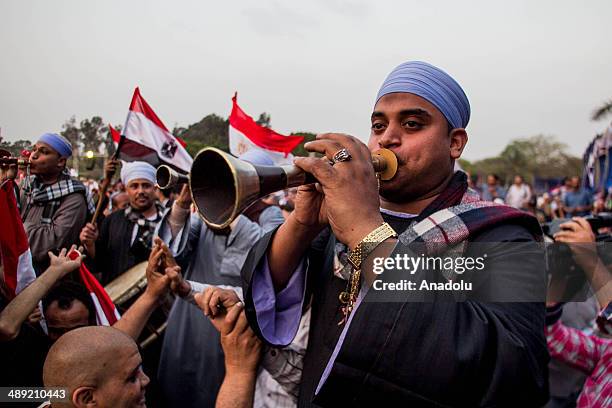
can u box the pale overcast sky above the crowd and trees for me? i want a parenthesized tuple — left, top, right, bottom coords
(0, 0, 612, 160)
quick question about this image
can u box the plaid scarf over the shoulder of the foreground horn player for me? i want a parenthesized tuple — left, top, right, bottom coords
(399, 171, 542, 254)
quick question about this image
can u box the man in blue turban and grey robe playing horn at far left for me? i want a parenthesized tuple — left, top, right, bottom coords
(20, 133, 94, 274)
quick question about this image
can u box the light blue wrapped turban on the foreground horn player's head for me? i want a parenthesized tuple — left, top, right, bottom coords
(376, 61, 470, 129)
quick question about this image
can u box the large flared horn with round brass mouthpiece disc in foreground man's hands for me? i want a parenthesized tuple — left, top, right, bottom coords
(189, 147, 397, 229)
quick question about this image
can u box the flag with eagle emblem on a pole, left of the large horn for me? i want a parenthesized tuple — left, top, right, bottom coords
(110, 88, 193, 173)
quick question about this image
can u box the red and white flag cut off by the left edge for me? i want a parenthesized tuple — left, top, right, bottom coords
(0, 180, 36, 297)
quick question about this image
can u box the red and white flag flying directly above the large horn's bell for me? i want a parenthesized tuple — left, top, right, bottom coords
(229, 93, 304, 165)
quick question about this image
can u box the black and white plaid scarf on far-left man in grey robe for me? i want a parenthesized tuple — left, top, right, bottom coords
(22, 171, 96, 224)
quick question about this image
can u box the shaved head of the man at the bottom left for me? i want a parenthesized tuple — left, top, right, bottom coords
(43, 326, 149, 408)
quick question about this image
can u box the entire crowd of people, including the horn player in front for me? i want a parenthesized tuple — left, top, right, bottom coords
(0, 62, 612, 407)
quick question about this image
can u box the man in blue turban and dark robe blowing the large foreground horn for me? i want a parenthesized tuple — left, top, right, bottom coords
(237, 62, 548, 407)
